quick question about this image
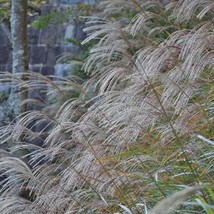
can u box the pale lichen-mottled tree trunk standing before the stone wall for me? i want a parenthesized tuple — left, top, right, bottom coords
(11, 0, 29, 113)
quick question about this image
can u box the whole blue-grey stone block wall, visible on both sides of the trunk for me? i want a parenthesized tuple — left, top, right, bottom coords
(0, 0, 94, 122)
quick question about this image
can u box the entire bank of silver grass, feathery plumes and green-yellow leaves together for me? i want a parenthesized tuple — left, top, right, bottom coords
(0, 0, 214, 214)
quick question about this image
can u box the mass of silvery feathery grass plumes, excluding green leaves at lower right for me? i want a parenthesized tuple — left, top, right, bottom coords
(0, 0, 214, 214)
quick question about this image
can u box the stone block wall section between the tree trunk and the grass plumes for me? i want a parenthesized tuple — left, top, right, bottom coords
(28, 0, 89, 76)
